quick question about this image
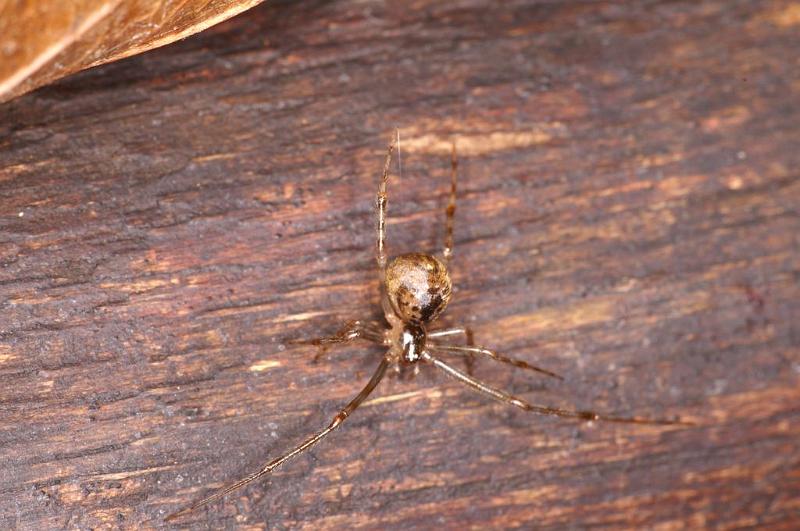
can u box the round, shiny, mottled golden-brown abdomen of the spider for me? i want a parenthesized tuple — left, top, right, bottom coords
(386, 253, 452, 323)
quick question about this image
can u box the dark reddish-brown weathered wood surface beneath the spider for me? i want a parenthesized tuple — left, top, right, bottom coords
(0, 0, 800, 529)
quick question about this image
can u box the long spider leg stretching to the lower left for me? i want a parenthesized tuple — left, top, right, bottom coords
(165, 358, 389, 522)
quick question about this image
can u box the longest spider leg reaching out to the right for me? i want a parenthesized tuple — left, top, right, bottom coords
(422, 352, 694, 426)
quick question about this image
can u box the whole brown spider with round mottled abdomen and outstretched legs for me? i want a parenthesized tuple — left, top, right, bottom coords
(166, 132, 692, 521)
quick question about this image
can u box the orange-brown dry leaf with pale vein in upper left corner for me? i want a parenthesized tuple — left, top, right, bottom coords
(0, 0, 263, 102)
